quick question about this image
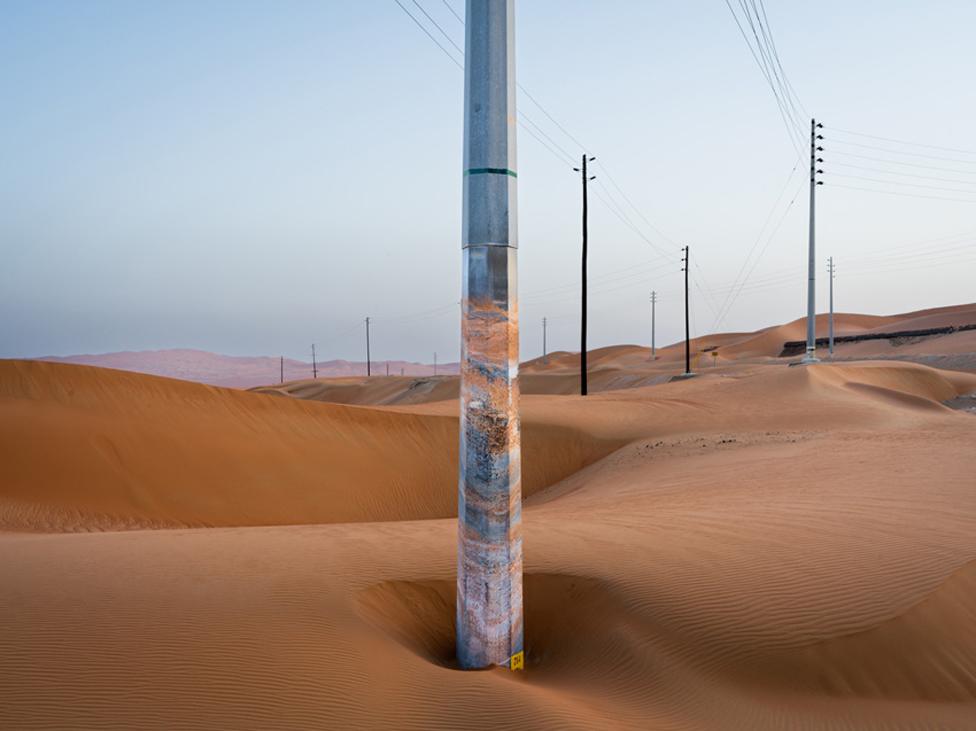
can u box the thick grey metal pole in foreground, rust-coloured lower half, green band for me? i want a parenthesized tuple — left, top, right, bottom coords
(456, 0, 524, 670)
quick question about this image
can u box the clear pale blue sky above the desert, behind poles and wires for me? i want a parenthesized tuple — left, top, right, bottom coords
(0, 0, 976, 361)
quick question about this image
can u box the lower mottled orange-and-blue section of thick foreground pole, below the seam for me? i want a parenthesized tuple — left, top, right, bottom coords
(456, 246, 523, 670)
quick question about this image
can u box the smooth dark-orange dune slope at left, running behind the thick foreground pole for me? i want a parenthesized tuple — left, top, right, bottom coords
(0, 361, 619, 531)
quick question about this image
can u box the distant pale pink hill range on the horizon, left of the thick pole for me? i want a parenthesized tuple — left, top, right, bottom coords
(36, 349, 458, 388)
